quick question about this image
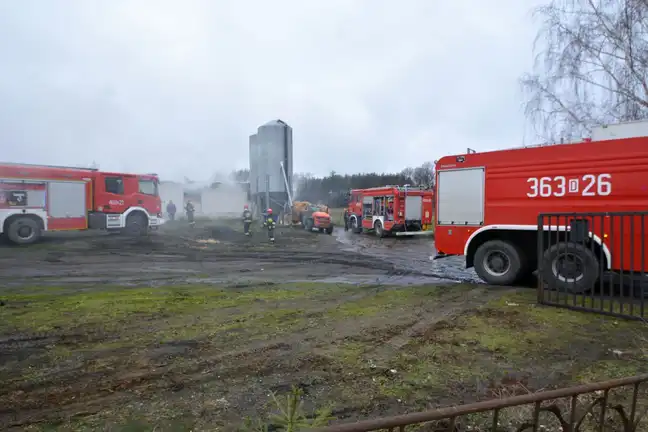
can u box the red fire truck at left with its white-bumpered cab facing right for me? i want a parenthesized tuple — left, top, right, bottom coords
(0, 163, 164, 244)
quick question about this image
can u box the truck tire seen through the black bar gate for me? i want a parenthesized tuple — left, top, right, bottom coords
(542, 242, 600, 294)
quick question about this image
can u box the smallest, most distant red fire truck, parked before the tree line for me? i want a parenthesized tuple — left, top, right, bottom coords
(347, 185, 434, 237)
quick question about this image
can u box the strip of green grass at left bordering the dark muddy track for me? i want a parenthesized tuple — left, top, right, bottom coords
(0, 283, 342, 336)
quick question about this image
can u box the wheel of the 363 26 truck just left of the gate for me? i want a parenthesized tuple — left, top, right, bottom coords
(474, 240, 523, 285)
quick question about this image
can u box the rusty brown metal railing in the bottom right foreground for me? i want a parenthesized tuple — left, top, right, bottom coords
(317, 374, 648, 432)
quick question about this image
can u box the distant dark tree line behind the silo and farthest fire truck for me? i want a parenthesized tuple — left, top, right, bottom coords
(231, 162, 434, 207)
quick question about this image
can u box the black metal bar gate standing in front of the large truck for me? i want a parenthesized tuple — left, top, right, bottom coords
(537, 212, 648, 319)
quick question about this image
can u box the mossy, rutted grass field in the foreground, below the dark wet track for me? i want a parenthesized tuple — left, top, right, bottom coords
(0, 283, 648, 430)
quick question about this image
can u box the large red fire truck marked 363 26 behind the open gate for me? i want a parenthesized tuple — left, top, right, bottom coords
(435, 120, 648, 292)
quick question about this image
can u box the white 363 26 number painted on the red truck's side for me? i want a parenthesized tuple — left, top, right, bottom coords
(527, 174, 612, 198)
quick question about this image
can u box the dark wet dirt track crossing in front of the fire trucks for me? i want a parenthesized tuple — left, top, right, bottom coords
(0, 222, 477, 285)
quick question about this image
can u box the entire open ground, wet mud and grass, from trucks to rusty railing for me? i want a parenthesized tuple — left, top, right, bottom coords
(0, 221, 648, 430)
